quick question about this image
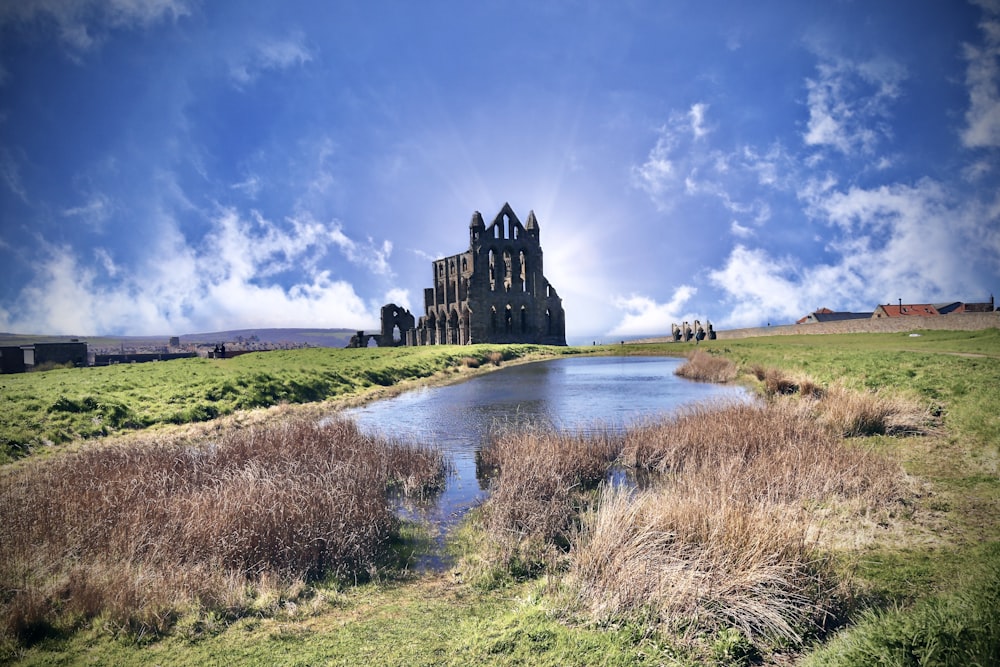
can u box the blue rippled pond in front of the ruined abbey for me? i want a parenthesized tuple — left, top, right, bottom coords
(341, 357, 747, 567)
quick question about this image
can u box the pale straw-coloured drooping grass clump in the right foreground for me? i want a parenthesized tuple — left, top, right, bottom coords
(571, 480, 828, 643)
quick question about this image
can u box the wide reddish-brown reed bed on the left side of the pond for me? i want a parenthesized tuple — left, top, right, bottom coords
(0, 420, 445, 641)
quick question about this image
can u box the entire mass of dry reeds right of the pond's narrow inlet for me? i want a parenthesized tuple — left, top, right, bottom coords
(482, 399, 907, 648)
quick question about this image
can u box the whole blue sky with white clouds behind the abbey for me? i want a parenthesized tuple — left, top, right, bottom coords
(0, 0, 1000, 342)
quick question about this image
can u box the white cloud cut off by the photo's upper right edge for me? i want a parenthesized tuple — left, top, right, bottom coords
(962, 3, 1000, 148)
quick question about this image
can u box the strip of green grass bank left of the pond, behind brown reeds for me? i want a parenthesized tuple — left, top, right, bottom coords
(0, 345, 576, 463)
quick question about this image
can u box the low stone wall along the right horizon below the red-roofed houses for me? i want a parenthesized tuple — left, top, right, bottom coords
(629, 311, 1000, 343)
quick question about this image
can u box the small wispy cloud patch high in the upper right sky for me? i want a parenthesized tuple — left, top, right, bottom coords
(802, 58, 906, 155)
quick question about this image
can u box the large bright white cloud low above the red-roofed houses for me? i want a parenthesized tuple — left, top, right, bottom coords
(709, 179, 1000, 327)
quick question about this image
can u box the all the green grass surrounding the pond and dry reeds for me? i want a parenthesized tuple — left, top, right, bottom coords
(0, 329, 1000, 665)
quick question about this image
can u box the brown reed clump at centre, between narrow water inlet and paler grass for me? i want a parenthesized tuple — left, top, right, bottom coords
(472, 427, 621, 574)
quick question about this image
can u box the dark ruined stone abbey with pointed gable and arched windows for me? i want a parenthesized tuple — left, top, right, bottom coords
(379, 204, 566, 346)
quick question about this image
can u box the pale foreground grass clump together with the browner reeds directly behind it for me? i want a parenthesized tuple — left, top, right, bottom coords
(571, 401, 905, 645)
